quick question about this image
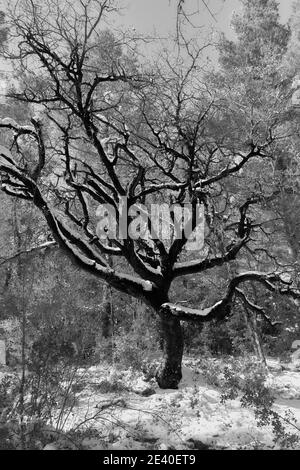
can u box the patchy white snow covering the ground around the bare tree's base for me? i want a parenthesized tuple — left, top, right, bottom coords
(50, 361, 300, 450)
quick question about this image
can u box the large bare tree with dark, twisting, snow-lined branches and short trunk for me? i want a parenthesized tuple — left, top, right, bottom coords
(0, 0, 300, 388)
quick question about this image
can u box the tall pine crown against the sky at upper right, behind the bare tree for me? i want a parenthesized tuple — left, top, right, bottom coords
(219, 0, 290, 144)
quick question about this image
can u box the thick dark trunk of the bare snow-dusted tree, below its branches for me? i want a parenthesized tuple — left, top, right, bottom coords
(156, 315, 183, 389)
